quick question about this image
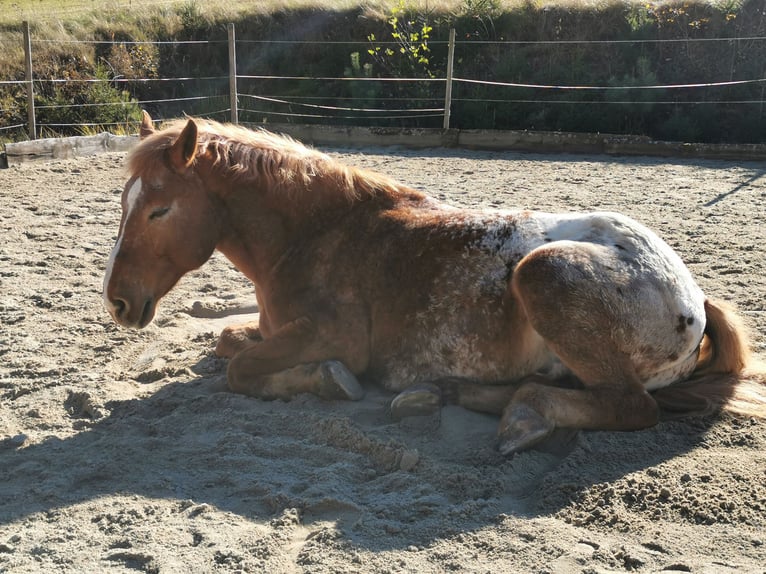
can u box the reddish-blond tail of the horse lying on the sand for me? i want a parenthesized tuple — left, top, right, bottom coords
(654, 299, 766, 419)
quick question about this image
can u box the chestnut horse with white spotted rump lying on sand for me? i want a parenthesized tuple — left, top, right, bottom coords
(103, 112, 766, 454)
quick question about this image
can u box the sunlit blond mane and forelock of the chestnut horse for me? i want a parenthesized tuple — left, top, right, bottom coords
(128, 119, 401, 198)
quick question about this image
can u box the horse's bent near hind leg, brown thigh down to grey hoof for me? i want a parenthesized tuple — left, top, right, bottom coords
(498, 242, 658, 453)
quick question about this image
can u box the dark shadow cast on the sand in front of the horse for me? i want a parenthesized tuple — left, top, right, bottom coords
(0, 358, 728, 551)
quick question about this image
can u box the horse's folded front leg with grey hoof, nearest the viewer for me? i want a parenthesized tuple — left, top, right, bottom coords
(227, 318, 364, 400)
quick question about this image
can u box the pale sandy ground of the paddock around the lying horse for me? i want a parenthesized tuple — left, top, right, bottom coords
(0, 145, 766, 574)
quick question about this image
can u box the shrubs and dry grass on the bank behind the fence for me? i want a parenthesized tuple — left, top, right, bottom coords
(0, 0, 766, 143)
